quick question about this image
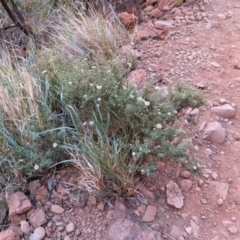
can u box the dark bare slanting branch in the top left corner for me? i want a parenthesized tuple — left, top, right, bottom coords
(0, 0, 35, 38)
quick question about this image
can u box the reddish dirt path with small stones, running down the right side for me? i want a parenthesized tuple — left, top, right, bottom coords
(134, 0, 240, 240)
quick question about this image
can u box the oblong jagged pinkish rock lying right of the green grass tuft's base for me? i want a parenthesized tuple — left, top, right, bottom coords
(166, 180, 184, 209)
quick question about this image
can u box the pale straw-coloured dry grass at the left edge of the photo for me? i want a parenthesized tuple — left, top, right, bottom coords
(0, 48, 44, 128)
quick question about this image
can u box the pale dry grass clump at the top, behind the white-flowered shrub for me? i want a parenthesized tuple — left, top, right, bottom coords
(54, 7, 128, 63)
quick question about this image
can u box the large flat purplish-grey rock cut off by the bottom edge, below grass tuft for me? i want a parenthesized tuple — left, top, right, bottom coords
(108, 219, 161, 240)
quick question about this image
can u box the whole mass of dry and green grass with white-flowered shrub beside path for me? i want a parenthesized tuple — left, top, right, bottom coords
(0, 5, 203, 196)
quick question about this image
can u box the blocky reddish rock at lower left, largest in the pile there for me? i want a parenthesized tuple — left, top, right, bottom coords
(7, 192, 32, 217)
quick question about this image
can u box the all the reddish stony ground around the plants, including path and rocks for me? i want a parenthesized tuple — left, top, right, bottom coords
(0, 0, 240, 240)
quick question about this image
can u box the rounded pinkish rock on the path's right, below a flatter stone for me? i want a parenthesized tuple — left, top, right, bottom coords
(203, 122, 226, 144)
